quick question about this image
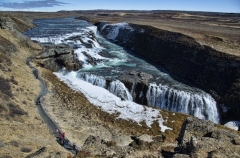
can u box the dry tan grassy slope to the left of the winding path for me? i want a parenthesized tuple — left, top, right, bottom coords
(0, 15, 70, 157)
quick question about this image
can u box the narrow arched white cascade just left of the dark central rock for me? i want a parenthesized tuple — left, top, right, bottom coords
(108, 80, 133, 101)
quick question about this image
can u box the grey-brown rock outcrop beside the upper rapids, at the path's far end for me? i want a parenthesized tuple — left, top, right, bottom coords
(36, 44, 81, 72)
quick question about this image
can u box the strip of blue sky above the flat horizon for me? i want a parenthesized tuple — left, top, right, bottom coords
(0, 0, 240, 13)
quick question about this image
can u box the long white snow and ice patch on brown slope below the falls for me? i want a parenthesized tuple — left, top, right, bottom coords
(54, 72, 172, 132)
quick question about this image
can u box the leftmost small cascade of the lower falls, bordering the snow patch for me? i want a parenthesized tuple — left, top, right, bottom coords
(78, 73, 106, 88)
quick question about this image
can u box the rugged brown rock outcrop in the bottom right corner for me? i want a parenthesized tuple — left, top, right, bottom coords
(178, 117, 240, 157)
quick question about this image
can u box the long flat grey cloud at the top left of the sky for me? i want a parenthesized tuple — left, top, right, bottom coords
(0, 0, 69, 9)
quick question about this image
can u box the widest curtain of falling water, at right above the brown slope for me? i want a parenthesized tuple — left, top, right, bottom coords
(146, 83, 219, 123)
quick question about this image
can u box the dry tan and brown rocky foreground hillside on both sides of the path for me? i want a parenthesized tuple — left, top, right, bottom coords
(0, 13, 240, 157)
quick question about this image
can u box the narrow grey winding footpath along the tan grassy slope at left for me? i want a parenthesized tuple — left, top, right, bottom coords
(26, 57, 81, 154)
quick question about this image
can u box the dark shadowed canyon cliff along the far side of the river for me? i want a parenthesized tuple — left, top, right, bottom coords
(96, 23, 240, 121)
